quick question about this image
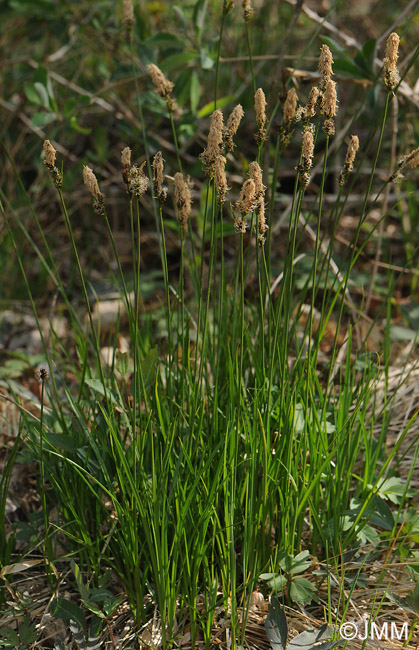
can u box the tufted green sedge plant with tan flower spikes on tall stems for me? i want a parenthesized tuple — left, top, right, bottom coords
(0, 2, 417, 648)
